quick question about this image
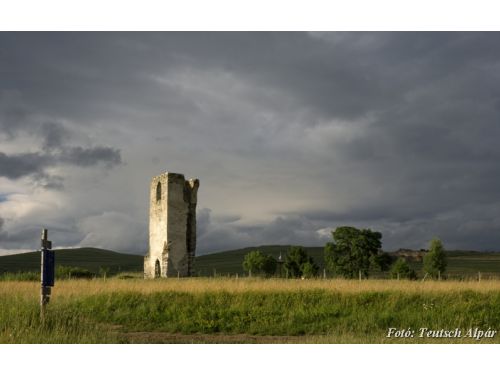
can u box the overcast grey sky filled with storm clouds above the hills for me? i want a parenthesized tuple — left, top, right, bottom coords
(0, 32, 500, 254)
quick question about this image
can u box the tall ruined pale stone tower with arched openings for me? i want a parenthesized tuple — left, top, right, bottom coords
(144, 172, 200, 279)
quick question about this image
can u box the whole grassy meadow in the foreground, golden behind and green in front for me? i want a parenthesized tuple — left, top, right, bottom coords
(0, 274, 500, 343)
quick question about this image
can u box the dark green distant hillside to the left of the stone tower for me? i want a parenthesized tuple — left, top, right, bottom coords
(0, 247, 143, 274)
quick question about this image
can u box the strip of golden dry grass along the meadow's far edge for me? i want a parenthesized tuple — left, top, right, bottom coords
(4, 277, 500, 298)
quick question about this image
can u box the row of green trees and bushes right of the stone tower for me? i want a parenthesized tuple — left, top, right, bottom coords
(243, 226, 447, 279)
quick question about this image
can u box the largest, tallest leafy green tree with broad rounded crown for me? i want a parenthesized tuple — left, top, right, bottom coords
(325, 227, 382, 278)
